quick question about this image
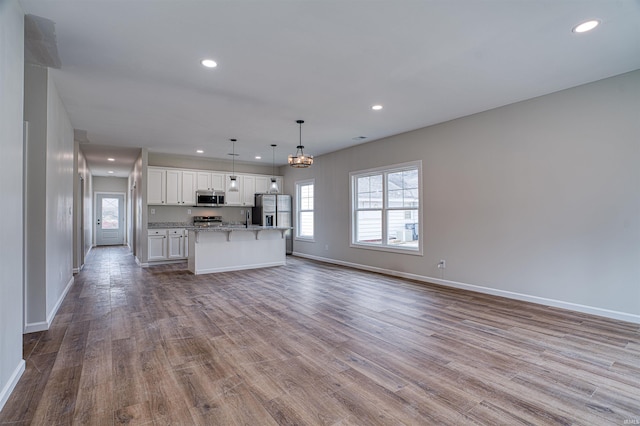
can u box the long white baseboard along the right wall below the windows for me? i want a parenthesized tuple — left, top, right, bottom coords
(293, 252, 640, 324)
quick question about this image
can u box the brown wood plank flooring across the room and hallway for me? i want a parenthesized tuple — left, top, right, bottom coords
(0, 247, 640, 425)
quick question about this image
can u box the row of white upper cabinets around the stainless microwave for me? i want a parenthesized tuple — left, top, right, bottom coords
(147, 166, 282, 207)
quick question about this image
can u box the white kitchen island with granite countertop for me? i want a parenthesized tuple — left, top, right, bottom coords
(188, 225, 291, 275)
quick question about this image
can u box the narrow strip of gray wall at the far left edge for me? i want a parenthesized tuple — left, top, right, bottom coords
(0, 1, 25, 409)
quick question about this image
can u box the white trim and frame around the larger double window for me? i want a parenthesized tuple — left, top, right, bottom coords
(349, 160, 424, 256)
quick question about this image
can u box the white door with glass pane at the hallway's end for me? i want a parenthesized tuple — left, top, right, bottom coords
(96, 194, 124, 246)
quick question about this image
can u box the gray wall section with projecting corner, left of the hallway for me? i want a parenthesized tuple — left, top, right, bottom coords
(24, 65, 75, 332)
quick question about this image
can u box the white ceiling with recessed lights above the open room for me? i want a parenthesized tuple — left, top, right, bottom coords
(21, 0, 640, 176)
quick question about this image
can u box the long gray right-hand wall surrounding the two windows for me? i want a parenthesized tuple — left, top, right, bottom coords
(281, 71, 640, 322)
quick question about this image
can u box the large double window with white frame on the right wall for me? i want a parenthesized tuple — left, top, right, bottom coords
(351, 161, 422, 254)
